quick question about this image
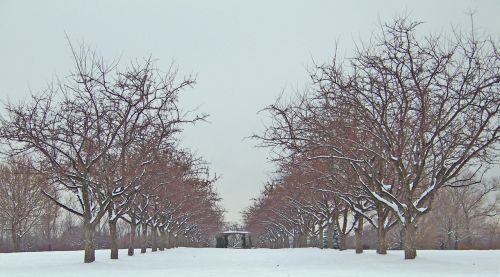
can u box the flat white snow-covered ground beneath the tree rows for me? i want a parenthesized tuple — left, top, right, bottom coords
(0, 248, 500, 277)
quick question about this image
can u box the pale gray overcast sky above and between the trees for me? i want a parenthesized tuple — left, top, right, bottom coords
(0, 0, 500, 221)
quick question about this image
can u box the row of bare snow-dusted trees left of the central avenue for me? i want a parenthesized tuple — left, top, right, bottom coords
(0, 42, 223, 263)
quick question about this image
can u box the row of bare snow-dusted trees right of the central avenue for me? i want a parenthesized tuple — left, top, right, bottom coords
(245, 17, 500, 259)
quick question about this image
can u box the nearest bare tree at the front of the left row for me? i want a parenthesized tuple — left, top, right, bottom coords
(0, 42, 203, 263)
